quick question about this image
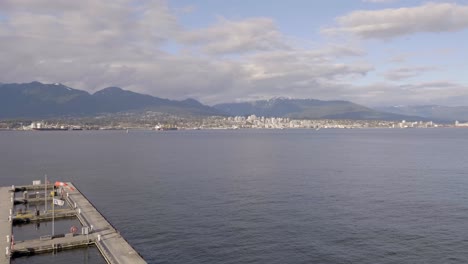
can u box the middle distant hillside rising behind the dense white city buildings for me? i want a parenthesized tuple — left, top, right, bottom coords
(214, 98, 424, 120)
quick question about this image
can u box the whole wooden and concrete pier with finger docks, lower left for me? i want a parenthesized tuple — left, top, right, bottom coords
(0, 182, 146, 264)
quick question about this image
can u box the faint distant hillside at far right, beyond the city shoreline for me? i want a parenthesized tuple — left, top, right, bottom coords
(378, 105, 468, 122)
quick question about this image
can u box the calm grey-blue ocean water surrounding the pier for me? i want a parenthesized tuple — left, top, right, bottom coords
(0, 129, 468, 264)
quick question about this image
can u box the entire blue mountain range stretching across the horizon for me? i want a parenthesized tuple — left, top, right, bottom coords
(0, 82, 462, 121)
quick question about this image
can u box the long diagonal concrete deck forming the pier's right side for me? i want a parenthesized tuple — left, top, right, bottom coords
(67, 182, 146, 264)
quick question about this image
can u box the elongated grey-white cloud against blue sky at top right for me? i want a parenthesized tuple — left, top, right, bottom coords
(322, 3, 468, 39)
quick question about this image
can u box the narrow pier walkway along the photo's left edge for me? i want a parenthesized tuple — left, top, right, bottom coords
(0, 187, 13, 264)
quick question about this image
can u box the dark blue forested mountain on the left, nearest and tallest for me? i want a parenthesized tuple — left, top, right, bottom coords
(0, 82, 223, 119)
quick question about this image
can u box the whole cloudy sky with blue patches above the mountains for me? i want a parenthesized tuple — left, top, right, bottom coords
(0, 0, 468, 106)
